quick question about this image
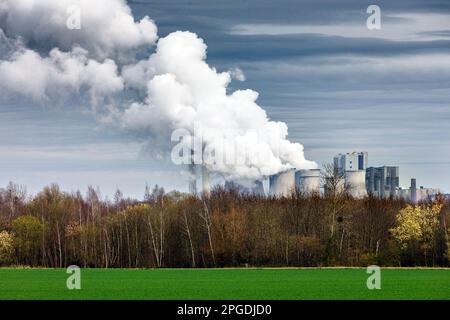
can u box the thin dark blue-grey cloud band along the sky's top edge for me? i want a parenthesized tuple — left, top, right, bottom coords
(128, 0, 450, 24)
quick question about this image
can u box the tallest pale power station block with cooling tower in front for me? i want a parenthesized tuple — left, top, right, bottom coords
(333, 152, 369, 198)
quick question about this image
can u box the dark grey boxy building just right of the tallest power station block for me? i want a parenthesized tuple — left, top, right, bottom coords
(366, 166, 400, 198)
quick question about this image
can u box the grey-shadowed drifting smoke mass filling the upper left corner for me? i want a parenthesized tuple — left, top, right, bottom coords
(0, 0, 157, 104)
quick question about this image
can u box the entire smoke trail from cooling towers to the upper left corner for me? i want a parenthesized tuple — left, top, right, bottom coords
(0, 0, 316, 179)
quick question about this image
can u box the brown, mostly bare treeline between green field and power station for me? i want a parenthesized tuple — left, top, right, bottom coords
(0, 183, 450, 268)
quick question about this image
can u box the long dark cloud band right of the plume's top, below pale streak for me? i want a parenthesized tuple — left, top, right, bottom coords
(207, 35, 450, 61)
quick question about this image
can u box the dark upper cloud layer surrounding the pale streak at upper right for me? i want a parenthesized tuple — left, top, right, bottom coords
(130, 0, 450, 63)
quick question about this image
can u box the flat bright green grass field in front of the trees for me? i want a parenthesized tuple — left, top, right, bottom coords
(0, 269, 450, 300)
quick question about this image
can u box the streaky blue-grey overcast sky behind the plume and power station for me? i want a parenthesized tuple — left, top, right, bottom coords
(0, 0, 450, 198)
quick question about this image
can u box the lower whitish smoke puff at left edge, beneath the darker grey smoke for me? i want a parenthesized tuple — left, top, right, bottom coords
(0, 48, 123, 103)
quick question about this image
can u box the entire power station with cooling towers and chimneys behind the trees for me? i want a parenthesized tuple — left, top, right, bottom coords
(189, 152, 440, 203)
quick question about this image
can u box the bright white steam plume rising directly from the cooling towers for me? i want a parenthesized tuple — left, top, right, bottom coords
(117, 31, 316, 179)
